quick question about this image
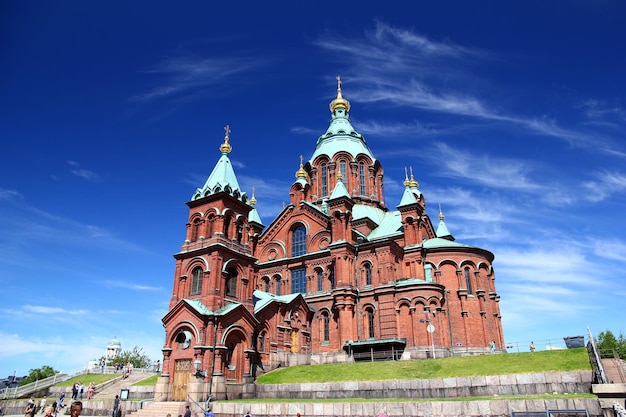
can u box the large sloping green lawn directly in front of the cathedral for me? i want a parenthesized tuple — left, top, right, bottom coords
(257, 348, 591, 384)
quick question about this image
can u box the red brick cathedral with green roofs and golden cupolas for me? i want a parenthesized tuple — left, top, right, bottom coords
(157, 80, 504, 401)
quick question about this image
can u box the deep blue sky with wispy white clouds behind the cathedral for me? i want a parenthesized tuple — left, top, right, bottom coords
(0, 0, 626, 376)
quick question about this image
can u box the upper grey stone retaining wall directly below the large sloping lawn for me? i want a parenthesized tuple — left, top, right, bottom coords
(256, 371, 593, 399)
